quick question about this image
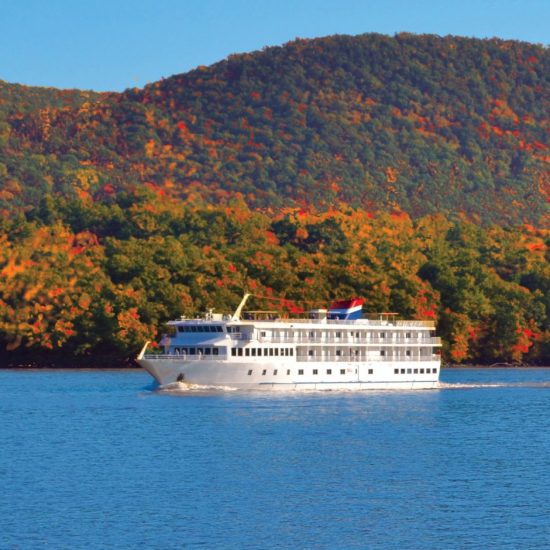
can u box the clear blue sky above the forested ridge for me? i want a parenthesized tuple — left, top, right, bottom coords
(0, 0, 550, 91)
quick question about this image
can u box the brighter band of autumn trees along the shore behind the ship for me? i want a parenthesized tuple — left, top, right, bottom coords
(0, 203, 550, 363)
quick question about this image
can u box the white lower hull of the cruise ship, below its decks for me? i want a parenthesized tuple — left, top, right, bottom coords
(138, 356, 439, 391)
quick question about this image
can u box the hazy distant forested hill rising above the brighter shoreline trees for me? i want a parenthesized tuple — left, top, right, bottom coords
(0, 34, 550, 226)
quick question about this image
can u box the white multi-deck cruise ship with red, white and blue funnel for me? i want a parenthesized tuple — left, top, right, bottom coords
(137, 294, 441, 391)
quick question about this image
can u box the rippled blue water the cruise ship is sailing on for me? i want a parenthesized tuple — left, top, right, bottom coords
(0, 369, 550, 550)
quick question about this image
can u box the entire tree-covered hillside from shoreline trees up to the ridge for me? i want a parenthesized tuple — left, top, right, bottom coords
(0, 35, 550, 365)
